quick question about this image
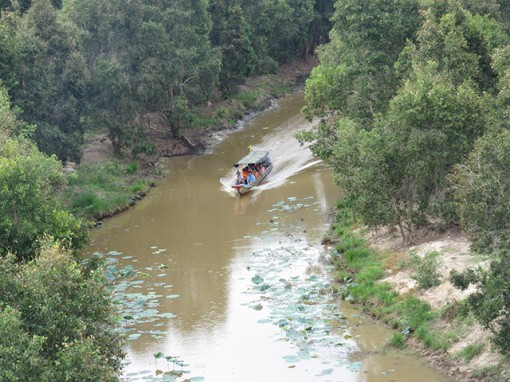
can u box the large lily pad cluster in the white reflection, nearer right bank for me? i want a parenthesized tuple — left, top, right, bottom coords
(237, 197, 360, 377)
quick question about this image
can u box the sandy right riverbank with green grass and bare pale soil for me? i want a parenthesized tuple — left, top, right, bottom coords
(325, 201, 510, 382)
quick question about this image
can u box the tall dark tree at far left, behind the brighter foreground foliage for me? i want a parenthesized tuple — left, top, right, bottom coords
(9, 0, 85, 162)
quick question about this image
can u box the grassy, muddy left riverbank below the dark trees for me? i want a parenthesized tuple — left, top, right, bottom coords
(63, 59, 317, 221)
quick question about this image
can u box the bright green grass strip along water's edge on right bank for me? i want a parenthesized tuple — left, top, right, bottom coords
(333, 201, 460, 350)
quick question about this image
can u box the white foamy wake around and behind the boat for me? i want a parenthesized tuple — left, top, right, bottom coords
(220, 109, 322, 196)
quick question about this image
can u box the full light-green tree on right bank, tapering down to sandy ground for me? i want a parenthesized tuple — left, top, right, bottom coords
(382, 64, 490, 242)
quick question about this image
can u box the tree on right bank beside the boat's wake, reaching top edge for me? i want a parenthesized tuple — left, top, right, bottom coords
(306, 0, 420, 129)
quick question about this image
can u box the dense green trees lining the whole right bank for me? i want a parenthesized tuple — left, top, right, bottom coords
(300, 0, 510, 353)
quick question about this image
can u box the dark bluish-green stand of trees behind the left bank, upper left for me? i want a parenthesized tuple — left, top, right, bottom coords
(0, 0, 333, 163)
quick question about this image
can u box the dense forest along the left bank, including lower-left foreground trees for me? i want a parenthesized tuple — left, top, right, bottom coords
(0, 0, 334, 382)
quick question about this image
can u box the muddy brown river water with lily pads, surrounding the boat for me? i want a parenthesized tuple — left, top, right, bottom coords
(85, 93, 448, 382)
